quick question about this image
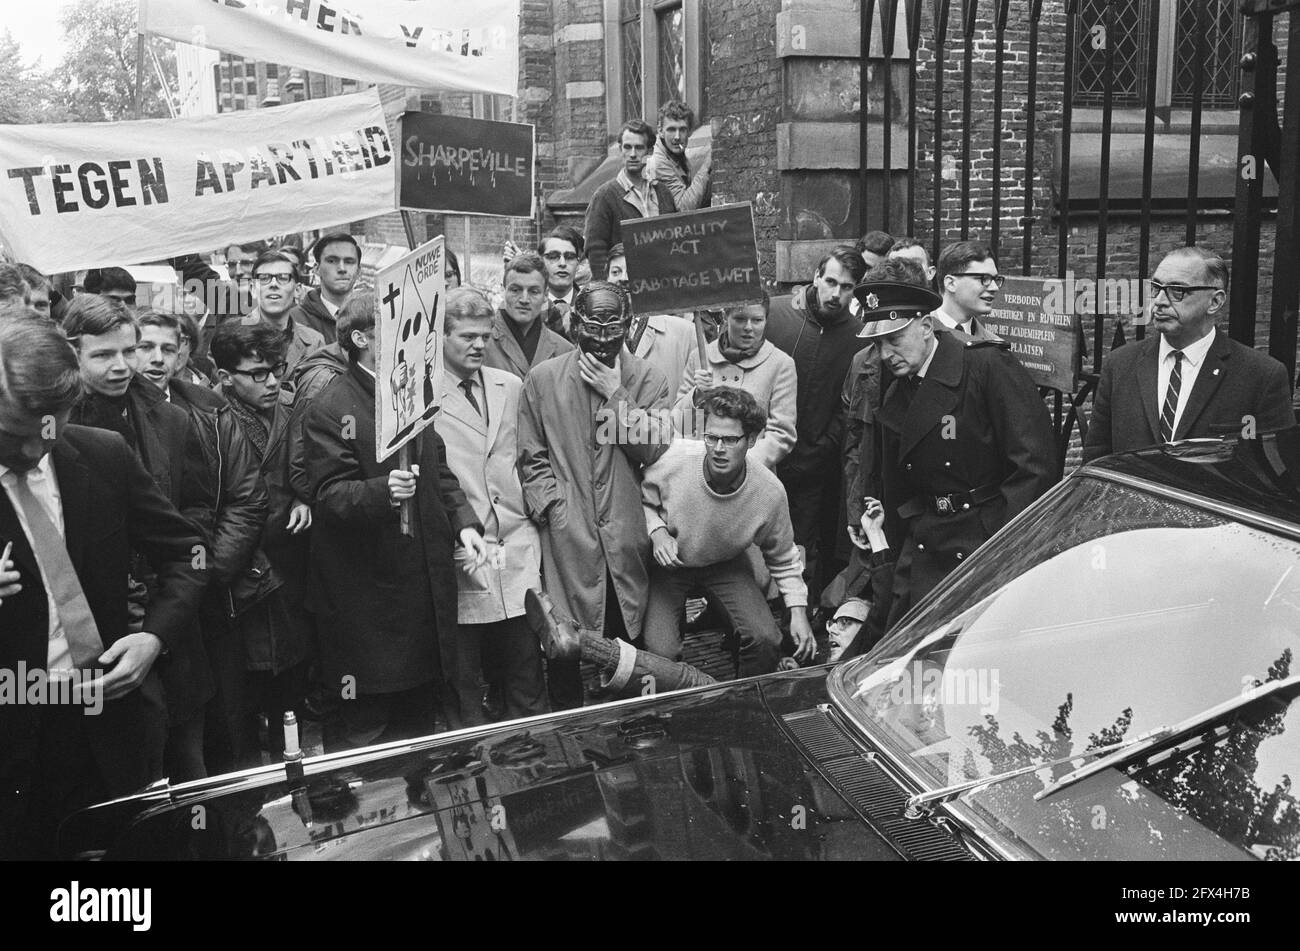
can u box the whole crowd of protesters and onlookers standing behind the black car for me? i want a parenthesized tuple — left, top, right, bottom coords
(0, 98, 1294, 856)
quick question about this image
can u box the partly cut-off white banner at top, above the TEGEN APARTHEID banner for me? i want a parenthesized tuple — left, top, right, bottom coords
(140, 0, 519, 96)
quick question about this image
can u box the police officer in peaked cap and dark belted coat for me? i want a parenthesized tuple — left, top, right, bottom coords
(854, 281, 1061, 626)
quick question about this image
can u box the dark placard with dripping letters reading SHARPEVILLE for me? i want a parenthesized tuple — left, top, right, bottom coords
(398, 112, 536, 218)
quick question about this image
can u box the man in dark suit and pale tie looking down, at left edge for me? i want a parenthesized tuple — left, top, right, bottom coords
(0, 320, 204, 859)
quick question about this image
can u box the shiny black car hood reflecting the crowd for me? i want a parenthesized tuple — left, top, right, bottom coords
(61, 668, 935, 861)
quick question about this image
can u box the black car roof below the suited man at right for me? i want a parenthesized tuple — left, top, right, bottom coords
(1076, 426, 1300, 538)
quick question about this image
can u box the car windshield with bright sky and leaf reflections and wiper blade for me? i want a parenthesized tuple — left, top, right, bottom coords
(829, 476, 1300, 859)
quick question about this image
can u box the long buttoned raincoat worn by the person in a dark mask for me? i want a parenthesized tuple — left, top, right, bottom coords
(519, 349, 672, 638)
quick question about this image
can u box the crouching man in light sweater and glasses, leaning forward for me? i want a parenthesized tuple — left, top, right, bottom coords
(641, 386, 816, 677)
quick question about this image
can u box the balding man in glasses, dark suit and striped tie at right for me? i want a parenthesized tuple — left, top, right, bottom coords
(1083, 247, 1295, 461)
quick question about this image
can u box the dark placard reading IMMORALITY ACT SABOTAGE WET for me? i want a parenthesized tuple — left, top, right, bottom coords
(623, 201, 763, 313)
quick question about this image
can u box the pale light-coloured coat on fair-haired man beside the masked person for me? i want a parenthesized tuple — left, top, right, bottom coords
(434, 366, 542, 624)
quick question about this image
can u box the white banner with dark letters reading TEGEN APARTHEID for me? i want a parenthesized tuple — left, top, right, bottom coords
(0, 88, 397, 274)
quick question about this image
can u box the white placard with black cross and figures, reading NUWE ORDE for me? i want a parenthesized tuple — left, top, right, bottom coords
(374, 236, 447, 462)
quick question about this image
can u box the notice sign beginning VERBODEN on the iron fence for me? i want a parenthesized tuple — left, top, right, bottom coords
(985, 277, 1079, 392)
